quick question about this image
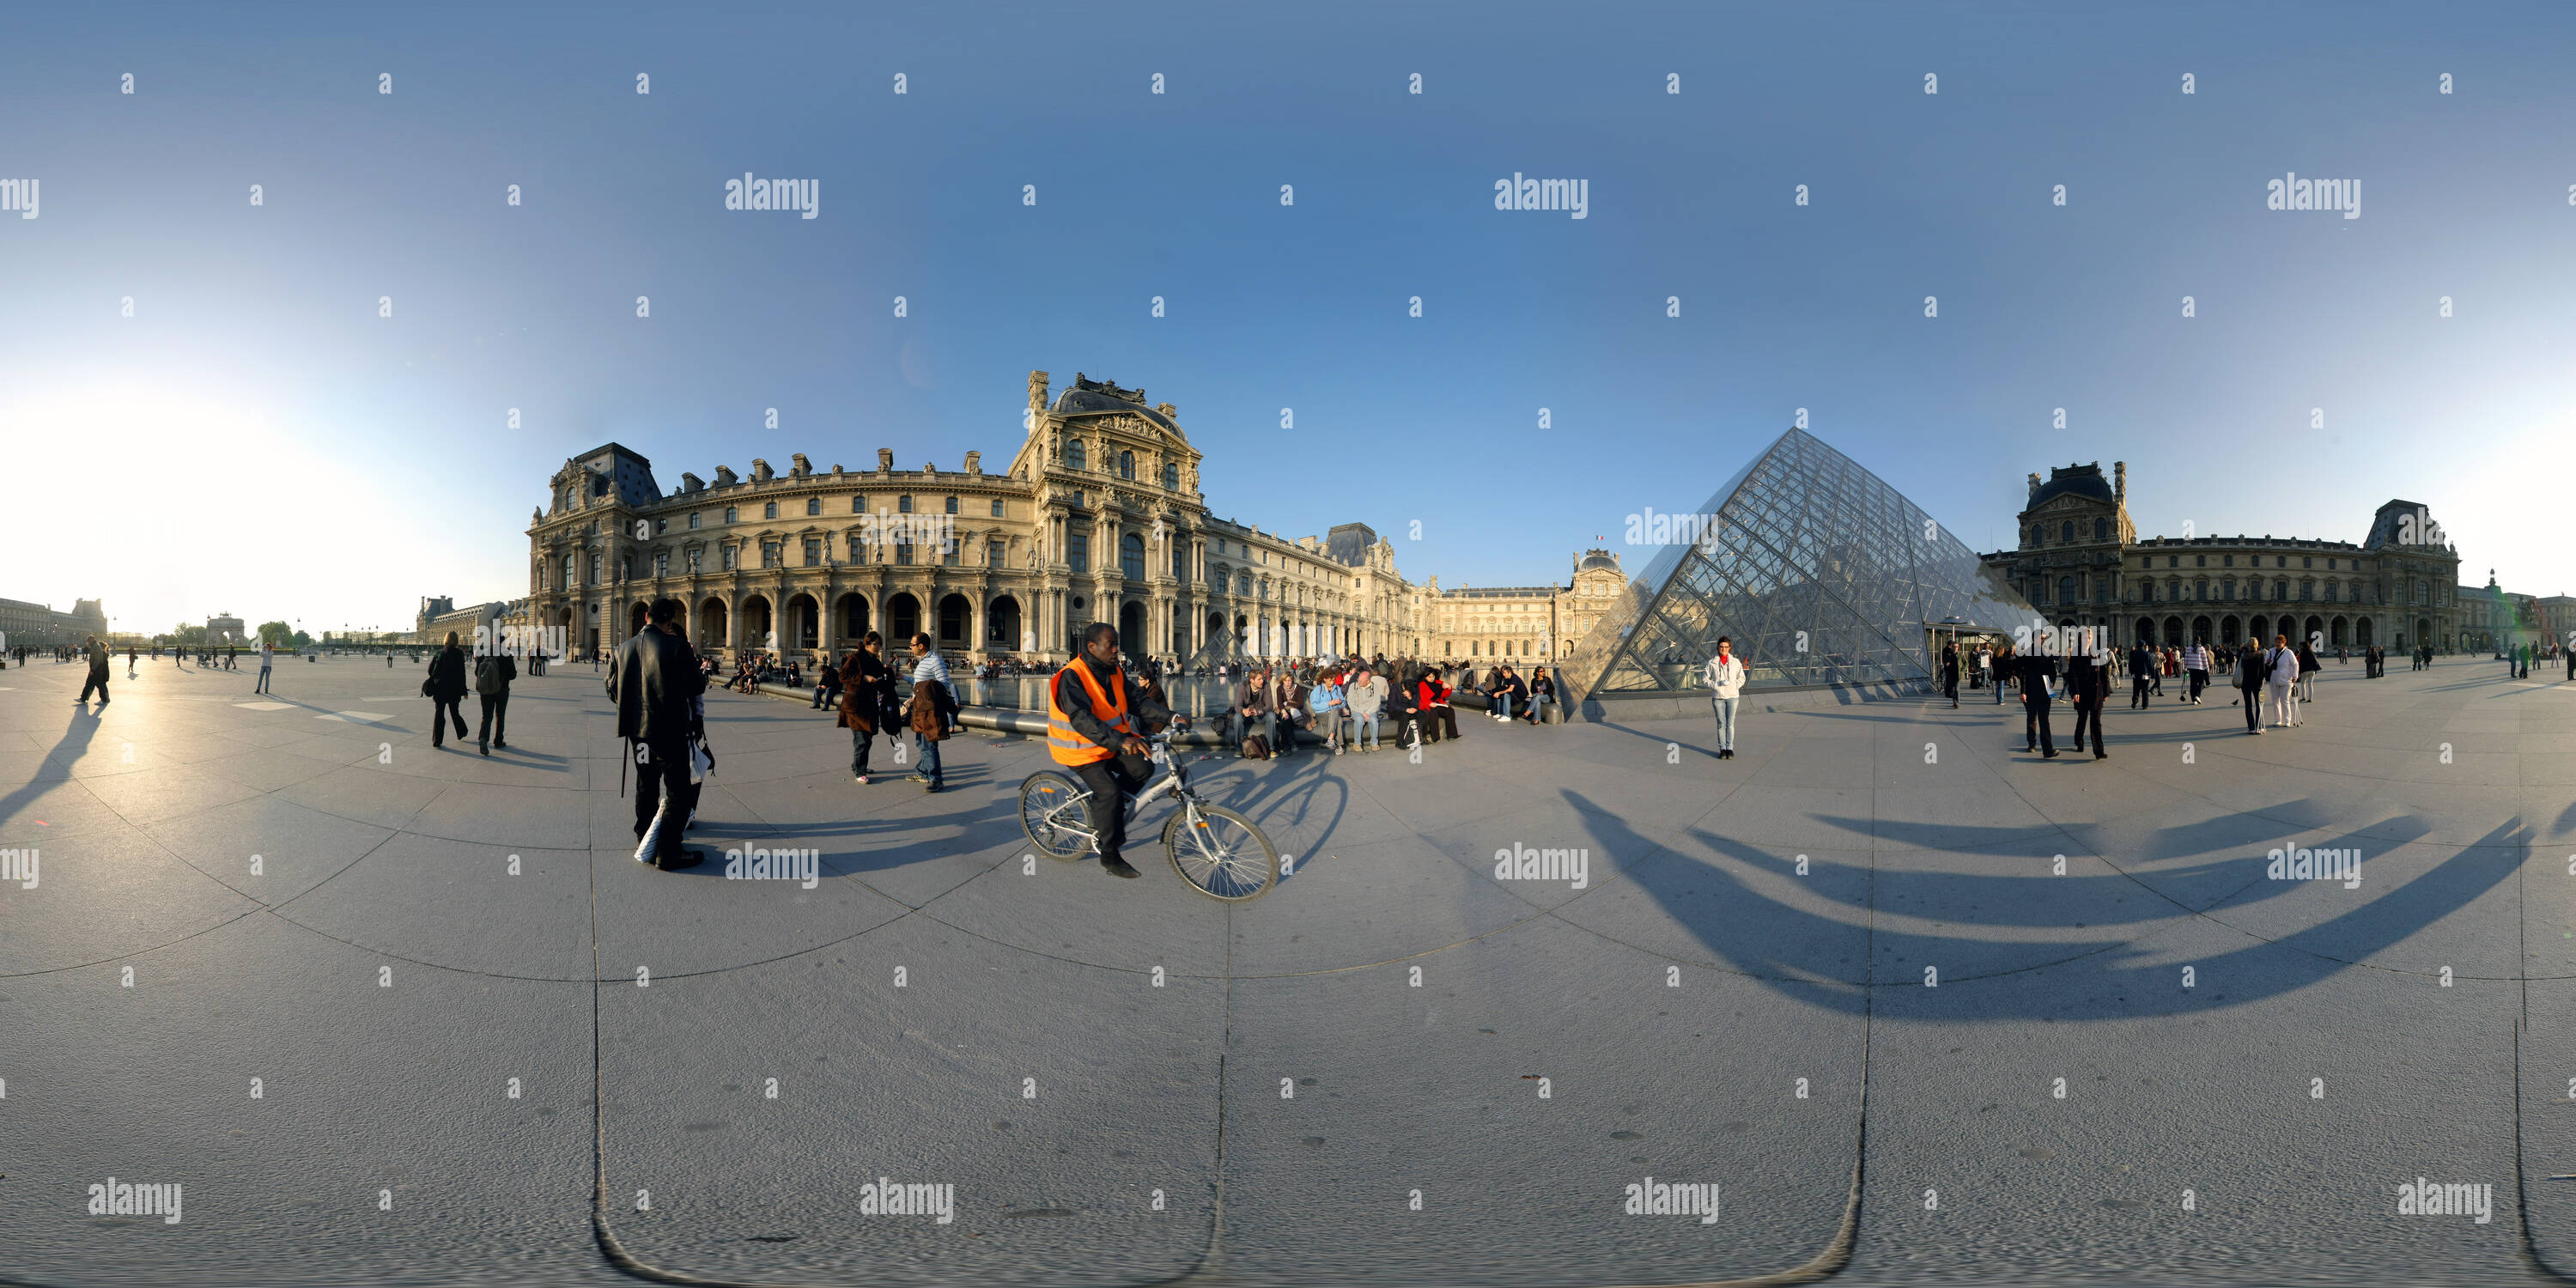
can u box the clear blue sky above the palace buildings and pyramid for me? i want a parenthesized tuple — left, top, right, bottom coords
(0, 3, 2576, 629)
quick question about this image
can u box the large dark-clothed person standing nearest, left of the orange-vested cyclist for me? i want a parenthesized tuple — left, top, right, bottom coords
(608, 600, 706, 871)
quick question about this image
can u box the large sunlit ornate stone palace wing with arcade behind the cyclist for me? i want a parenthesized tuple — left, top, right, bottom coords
(513, 371, 1430, 665)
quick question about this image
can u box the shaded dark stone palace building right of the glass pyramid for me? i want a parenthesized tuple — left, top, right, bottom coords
(1981, 461, 2463, 649)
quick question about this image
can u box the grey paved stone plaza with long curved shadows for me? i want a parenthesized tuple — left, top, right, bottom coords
(0, 659, 2576, 1285)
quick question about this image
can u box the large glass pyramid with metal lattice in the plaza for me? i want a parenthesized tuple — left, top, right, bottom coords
(1574, 430, 2040, 696)
